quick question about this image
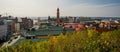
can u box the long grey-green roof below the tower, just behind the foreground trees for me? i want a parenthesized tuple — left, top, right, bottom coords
(26, 26, 74, 36)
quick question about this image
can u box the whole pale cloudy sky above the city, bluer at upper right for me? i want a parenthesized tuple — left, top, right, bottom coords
(0, 0, 120, 17)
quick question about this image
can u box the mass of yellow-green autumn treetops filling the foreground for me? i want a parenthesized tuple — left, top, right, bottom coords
(0, 30, 120, 52)
